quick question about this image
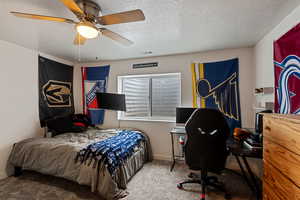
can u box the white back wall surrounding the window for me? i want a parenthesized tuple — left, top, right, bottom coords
(74, 48, 254, 160)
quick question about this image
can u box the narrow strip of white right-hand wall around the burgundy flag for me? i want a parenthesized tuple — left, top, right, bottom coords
(254, 3, 300, 103)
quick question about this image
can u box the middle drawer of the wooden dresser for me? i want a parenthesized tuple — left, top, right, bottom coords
(263, 138, 300, 187)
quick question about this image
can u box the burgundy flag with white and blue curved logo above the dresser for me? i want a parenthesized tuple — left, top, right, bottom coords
(274, 24, 300, 114)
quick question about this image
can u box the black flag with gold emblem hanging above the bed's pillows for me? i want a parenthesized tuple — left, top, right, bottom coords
(38, 56, 74, 127)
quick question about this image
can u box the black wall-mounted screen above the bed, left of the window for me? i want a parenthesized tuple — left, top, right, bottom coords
(96, 92, 126, 111)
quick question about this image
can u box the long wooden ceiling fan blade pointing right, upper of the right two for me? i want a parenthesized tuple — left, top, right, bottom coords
(97, 9, 145, 25)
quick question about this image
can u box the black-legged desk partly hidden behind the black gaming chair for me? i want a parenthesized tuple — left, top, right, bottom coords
(170, 128, 263, 200)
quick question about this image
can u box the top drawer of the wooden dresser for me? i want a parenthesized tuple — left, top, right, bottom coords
(263, 115, 300, 156)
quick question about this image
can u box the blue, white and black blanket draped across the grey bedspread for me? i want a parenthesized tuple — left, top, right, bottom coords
(76, 130, 145, 175)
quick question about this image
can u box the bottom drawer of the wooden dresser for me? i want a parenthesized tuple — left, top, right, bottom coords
(263, 161, 300, 200)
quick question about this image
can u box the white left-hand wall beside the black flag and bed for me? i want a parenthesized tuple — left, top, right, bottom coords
(0, 40, 72, 179)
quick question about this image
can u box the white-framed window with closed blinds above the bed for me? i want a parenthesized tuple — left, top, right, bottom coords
(118, 73, 181, 122)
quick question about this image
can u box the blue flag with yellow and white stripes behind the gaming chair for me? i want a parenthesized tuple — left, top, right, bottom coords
(191, 59, 241, 131)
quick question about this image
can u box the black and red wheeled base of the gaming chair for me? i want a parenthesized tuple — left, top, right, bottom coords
(177, 171, 231, 200)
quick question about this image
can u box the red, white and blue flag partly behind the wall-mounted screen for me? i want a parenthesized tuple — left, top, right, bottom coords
(81, 66, 110, 125)
